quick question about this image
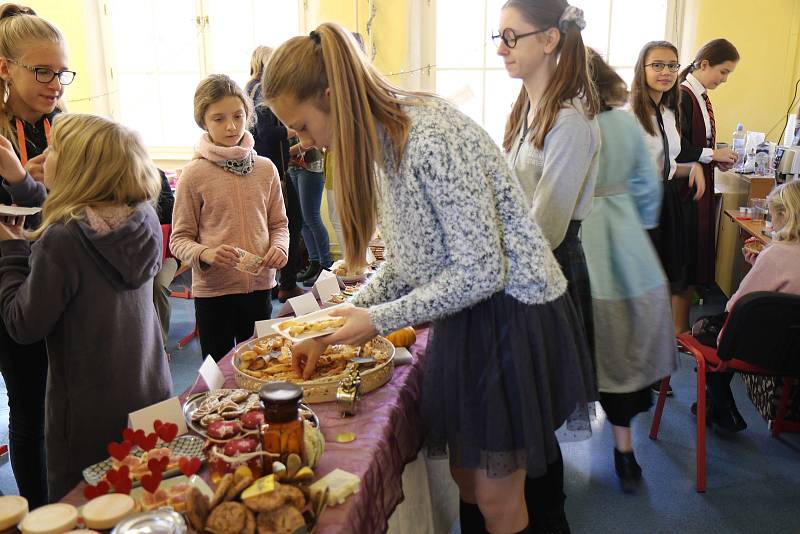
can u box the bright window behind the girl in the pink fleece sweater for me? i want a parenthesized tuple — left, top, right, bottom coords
(101, 0, 301, 157)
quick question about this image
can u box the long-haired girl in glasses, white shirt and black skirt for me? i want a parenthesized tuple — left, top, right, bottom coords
(631, 41, 706, 348)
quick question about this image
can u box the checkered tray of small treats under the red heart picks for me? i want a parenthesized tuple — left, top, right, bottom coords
(83, 434, 205, 486)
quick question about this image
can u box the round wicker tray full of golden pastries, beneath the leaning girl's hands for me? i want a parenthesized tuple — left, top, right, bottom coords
(233, 334, 395, 403)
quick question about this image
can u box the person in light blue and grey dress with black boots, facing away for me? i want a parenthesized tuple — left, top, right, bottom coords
(583, 49, 677, 492)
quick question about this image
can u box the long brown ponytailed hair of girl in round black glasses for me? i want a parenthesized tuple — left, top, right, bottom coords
(503, 0, 599, 152)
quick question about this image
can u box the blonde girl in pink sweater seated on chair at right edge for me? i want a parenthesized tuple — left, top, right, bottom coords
(707, 180, 800, 432)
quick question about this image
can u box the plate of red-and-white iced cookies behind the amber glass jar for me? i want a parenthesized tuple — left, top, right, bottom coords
(183, 390, 319, 440)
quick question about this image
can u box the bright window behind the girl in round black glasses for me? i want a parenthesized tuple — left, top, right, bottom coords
(435, 0, 675, 143)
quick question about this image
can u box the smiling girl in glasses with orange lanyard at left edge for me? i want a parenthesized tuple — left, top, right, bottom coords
(0, 4, 75, 508)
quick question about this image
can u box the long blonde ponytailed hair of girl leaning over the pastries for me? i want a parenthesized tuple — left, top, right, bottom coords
(261, 23, 422, 267)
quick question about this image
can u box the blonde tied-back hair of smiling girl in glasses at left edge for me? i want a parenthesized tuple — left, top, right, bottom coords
(0, 4, 64, 150)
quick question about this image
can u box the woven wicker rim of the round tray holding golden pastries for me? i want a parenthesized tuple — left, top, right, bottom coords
(233, 334, 394, 404)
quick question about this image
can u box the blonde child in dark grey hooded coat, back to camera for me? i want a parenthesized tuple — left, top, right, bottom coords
(0, 115, 171, 501)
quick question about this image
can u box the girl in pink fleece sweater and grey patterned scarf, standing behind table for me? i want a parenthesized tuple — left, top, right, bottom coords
(170, 74, 289, 361)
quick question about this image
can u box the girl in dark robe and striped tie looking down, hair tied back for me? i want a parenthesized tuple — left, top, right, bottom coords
(675, 39, 739, 332)
